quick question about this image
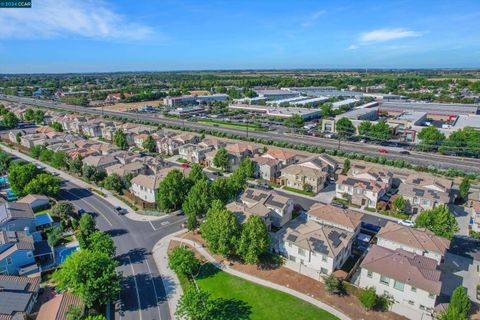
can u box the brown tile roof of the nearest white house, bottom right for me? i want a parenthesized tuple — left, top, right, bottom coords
(361, 245, 442, 295)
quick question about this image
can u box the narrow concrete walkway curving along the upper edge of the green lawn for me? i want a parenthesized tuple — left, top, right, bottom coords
(171, 235, 351, 320)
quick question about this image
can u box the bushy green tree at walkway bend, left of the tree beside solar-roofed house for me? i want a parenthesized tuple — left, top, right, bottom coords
(200, 200, 240, 256)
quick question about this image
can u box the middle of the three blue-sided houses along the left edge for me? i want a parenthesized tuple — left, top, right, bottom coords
(0, 231, 39, 275)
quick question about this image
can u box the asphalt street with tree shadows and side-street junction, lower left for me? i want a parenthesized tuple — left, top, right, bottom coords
(55, 182, 184, 320)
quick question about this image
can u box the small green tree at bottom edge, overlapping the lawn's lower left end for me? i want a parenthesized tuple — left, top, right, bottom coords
(175, 286, 215, 320)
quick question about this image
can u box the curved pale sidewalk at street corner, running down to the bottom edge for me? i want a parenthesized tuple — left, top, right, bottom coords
(152, 229, 187, 319)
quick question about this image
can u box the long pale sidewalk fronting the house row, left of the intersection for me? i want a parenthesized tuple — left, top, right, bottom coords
(0, 145, 162, 221)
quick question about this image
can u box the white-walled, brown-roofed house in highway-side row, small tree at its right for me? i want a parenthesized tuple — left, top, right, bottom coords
(335, 165, 393, 208)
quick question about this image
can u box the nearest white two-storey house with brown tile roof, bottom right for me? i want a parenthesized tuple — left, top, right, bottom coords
(358, 245, 442, 320)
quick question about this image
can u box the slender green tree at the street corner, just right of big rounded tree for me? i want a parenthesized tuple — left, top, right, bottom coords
(182, 179, 212, 230)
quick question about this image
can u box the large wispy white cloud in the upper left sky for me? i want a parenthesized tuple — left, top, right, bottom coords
(0, 0, 154, 41)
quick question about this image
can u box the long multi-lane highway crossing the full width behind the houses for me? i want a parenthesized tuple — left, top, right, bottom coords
(1, 96, 480, 172)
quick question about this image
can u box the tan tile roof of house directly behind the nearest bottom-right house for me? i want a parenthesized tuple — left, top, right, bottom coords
(377, 221, 450, 255)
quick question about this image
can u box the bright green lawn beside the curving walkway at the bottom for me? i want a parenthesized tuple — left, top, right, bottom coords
(197, 264, 338, 320)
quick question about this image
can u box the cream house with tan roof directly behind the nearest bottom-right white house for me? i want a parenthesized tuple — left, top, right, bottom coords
(377, 221, 450, 264)
